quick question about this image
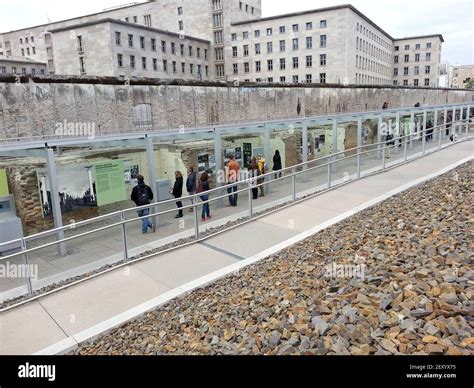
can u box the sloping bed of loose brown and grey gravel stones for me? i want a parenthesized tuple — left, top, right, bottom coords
(74, 162, 474, 355)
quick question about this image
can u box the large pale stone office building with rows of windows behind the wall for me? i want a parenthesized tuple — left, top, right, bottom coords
(0, 0, 443, 87)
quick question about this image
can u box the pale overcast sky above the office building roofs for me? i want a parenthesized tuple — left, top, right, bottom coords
(0, 0, 474, 64)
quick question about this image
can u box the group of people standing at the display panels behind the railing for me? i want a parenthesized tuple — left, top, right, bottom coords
(131, 150, 282, 234)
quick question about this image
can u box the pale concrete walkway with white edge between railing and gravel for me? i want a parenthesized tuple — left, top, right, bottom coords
(0, 140, 474, 354)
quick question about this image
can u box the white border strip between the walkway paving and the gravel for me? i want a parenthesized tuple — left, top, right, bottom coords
(34, 155, 474, 355)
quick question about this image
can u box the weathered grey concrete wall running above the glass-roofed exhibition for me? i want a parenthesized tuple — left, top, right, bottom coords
(0, 82, 474, 138)
